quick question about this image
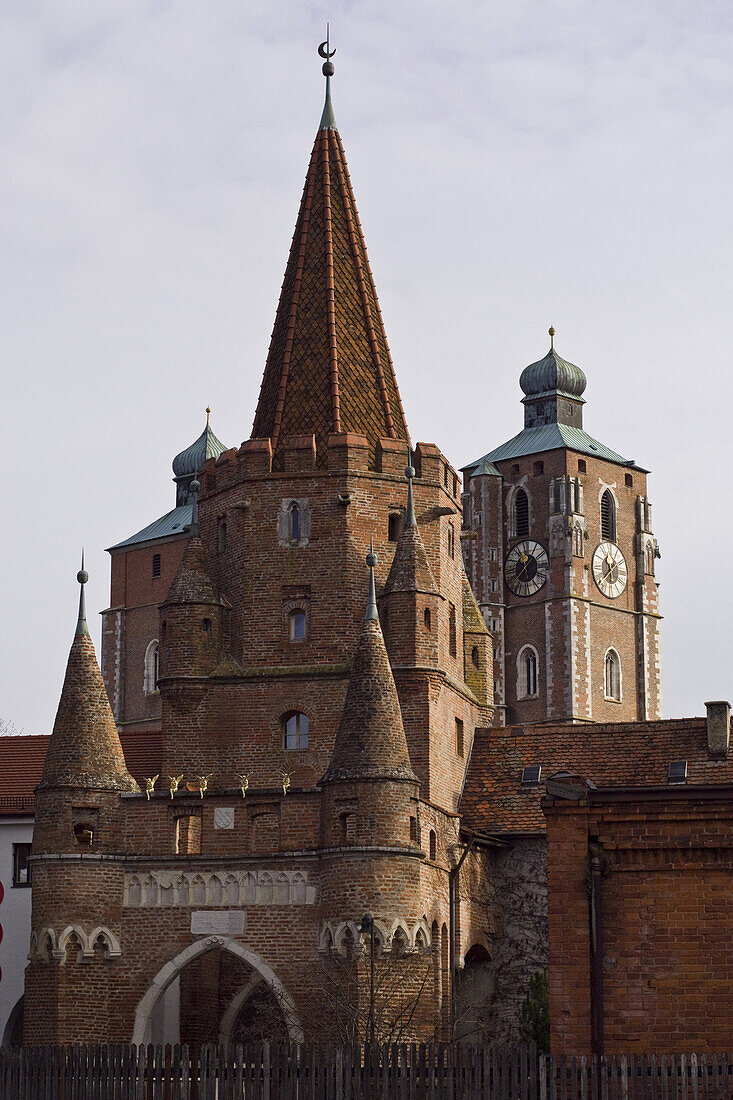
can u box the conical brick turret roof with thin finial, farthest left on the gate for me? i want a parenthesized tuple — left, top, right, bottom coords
(39, 563, 139, 791)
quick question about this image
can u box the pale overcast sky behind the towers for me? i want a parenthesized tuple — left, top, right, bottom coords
(0, 0, 733, 733)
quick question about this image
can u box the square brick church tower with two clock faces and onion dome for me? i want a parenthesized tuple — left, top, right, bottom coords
(461, 328, 661, 725)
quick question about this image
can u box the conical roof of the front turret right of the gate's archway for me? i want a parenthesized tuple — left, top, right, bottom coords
(321, 553, 417, 783)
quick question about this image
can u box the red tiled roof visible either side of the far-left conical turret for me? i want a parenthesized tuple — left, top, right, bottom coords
(0, 730, 163, 816)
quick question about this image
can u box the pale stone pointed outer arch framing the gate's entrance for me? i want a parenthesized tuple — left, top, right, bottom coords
(132, 936, 303, 1046)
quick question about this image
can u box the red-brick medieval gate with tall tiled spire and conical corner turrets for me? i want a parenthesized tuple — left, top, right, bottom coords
(25, 43, 493, 1043)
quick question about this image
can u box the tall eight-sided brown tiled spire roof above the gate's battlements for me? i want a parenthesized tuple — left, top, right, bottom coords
(252, 123, 408, 464)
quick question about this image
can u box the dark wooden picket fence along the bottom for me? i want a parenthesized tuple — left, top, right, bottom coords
(0, 1043, 733, 1100)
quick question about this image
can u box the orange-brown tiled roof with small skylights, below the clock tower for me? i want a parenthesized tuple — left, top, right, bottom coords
(460, 718, 733, 834)
